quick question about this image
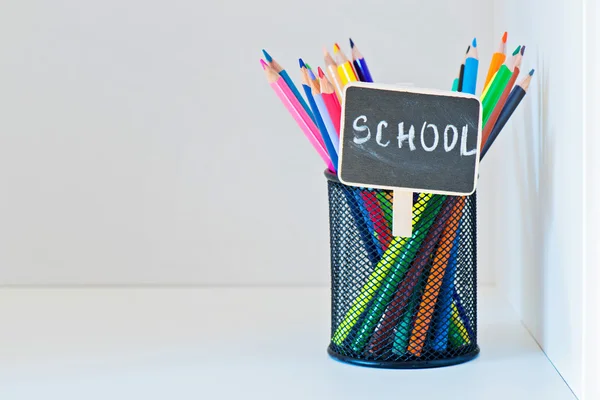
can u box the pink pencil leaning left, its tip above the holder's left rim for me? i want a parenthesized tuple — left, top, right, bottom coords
(260, 60, 336, 172)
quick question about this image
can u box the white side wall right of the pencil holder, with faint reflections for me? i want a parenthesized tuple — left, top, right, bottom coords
(488, 0, 584, 396)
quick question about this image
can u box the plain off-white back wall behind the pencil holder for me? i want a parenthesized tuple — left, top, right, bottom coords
(0, 0, 494, 284)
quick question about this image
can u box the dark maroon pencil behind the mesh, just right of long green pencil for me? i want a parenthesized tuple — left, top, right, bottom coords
(368, 197, 456, 353)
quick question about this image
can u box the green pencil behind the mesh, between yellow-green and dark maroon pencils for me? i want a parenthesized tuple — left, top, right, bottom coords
(352, 195, 446, 353)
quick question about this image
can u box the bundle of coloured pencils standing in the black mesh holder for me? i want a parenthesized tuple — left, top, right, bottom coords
(260, 32, 534, 360)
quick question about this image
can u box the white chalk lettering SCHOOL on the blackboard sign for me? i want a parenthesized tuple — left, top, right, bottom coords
(352, 115, 477, 156)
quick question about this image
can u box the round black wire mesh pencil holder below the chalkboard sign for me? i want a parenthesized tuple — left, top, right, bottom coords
(325, 172, 479, 368)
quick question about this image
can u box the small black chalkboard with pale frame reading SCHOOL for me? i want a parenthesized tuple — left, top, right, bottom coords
(339, 82, 481, 196)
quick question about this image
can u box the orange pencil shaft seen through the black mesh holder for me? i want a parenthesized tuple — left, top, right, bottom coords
(407, 196, 465, 357)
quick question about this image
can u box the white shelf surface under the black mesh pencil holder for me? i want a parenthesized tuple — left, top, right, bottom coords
(0, 287, 575, 400)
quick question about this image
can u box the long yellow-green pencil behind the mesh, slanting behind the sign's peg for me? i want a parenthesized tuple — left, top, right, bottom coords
(331, 193, 432, 345)
